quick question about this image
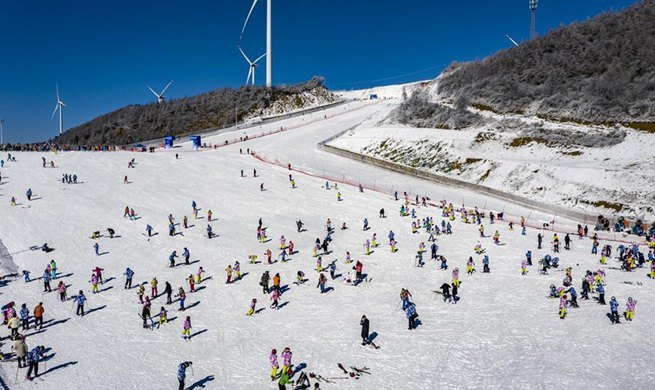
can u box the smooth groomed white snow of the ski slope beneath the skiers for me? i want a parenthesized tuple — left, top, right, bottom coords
(0, 97, 655, 389)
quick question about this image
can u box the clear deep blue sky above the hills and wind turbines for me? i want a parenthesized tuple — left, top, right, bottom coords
(0, 0, 636, 142)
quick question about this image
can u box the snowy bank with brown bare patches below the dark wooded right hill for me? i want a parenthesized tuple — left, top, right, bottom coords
(330, 79, 655, 221)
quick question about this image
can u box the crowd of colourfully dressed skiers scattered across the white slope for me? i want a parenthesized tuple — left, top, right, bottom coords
(1, 149, 655, 390)
